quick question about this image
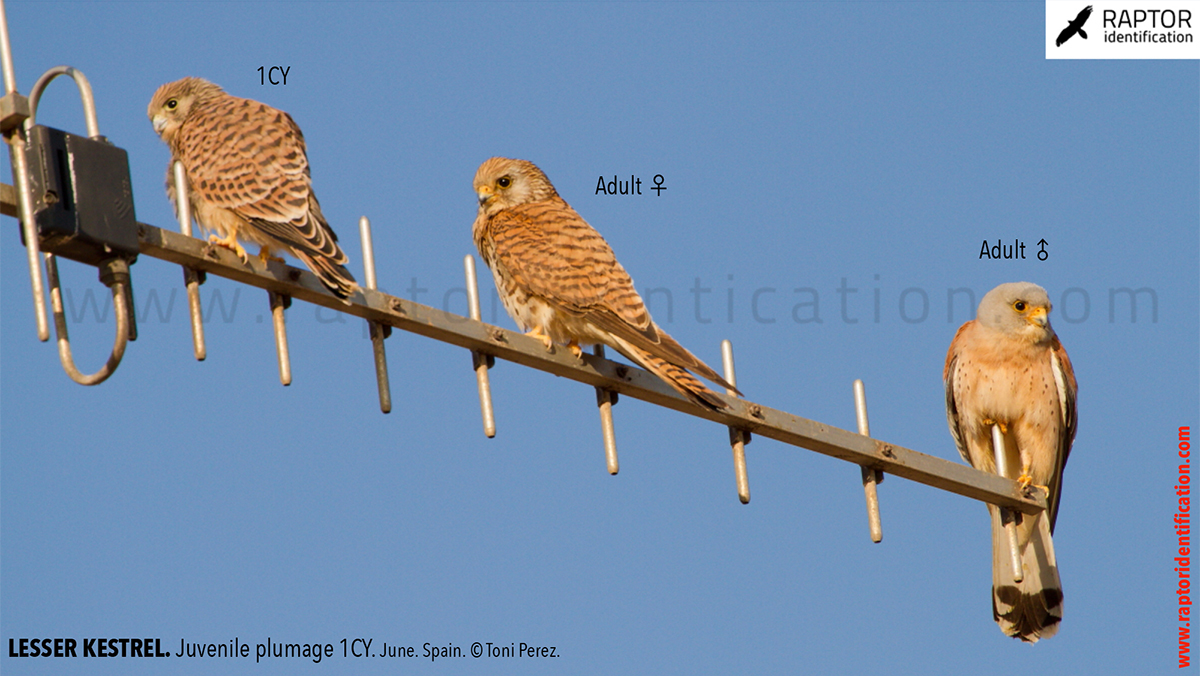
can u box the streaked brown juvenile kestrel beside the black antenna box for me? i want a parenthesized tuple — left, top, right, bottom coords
(146, 78, 358, 300)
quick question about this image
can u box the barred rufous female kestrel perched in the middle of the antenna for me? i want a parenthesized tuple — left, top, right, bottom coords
(473, 157, 740, 409)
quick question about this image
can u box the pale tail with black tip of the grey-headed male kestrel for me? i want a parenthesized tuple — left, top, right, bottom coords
(988, 505, 1062, 644)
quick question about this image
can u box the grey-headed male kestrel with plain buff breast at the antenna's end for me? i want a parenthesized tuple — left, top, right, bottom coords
(942, 282, 1078, 642)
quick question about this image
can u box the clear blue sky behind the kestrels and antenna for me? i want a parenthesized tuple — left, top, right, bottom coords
(0, 1, 1200, 675)
